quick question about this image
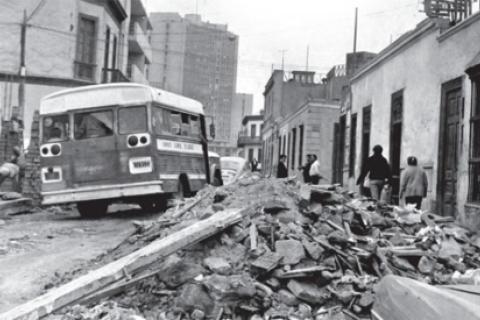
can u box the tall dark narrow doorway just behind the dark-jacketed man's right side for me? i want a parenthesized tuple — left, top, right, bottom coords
(390, 90, 403, 205)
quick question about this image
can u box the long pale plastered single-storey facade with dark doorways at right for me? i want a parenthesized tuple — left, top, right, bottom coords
(344, 13, 480, 228)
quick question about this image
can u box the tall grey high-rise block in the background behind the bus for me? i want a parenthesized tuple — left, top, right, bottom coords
(149, 12, 241, 155)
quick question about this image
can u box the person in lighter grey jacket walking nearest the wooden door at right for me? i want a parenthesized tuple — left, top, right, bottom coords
(400, 156, 428, 210)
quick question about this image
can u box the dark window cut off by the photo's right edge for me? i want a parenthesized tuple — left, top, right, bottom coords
(468, 77, 480, 202)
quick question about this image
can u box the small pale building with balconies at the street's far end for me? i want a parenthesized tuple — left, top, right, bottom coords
(237, 114, 263, 163)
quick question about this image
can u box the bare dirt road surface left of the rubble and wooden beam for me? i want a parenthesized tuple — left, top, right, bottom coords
(0, 206, 161, 313)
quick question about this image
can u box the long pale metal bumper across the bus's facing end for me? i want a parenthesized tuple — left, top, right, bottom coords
(42, 181, 163, 205)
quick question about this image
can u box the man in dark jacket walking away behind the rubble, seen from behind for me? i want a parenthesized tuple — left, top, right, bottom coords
(357, 145, 392, 200)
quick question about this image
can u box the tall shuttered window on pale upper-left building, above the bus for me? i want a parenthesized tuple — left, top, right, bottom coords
(74, 16, 97, 81)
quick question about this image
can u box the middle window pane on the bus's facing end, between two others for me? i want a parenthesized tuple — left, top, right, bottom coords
(74, 110, 113, 140)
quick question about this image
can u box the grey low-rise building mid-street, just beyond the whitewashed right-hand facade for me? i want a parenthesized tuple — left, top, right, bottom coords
(262, 66, 347, 178)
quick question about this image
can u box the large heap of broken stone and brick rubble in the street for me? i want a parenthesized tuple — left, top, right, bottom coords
(54, 175, 480, 320)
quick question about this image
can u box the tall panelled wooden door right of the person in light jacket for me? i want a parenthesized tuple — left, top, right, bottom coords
(439, 81, 462, 216)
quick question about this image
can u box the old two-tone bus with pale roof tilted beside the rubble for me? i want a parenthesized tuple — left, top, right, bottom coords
(40, 83, 210, 216)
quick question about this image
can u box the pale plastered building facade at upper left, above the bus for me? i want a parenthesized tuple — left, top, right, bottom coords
(0, 0, 152, 144)
